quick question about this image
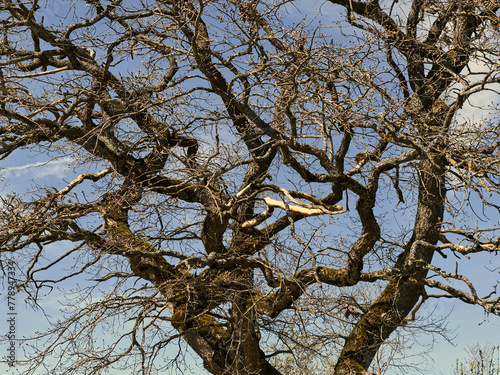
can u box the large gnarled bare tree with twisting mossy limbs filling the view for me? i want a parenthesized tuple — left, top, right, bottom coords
(0, 0, 500, 375)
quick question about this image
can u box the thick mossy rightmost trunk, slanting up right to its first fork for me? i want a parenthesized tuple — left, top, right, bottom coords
(334, 157, 445, 375)
